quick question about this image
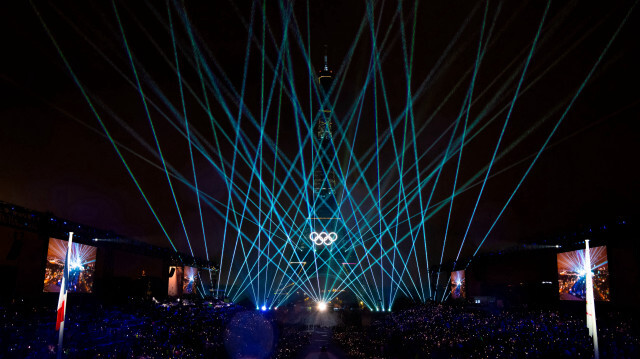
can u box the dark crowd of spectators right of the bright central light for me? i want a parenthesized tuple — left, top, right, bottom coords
(333, 305, 640, 358)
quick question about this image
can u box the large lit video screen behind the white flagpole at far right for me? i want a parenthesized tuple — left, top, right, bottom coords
(558, 246, 609, 302)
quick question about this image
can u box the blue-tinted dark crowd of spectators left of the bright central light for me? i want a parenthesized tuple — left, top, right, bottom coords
(0, 300, 309, 359)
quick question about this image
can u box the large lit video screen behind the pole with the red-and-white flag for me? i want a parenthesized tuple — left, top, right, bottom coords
(43, 238, 97, 293)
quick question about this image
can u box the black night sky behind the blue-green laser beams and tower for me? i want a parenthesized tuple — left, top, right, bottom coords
(0, 1, 640, 272)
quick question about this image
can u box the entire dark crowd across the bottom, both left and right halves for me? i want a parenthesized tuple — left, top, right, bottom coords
(0, 299, 640, 359)
